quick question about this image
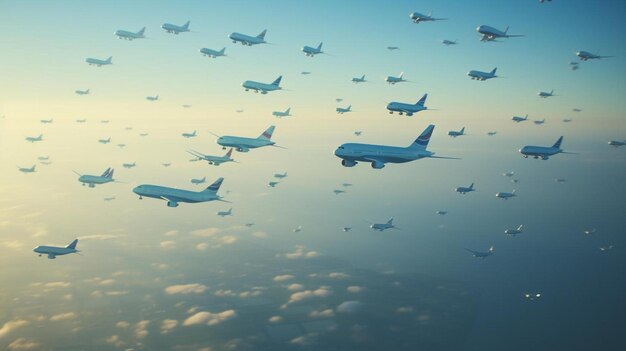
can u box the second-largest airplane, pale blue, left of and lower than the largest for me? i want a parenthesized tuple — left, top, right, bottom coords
(133, 177, 228, 207)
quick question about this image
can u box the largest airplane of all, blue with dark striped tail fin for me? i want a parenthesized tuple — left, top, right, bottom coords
(335, 124, 452, 169)
